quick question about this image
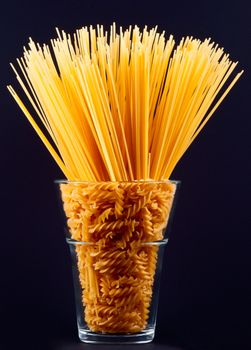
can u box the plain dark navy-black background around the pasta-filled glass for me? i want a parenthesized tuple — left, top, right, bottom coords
(0, 0, 251, 350)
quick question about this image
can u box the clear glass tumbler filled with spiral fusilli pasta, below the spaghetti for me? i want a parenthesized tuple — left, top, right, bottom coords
(56, 180, 179, 344)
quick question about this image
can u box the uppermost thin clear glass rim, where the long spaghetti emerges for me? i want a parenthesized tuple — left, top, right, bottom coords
(54, 179, 181, 185)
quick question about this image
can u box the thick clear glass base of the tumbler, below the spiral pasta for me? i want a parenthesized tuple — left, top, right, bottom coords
(78, 328, 155, 344)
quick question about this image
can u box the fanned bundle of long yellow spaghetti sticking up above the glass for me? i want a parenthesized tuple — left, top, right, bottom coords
(8, 24, 242, 181)
